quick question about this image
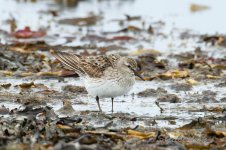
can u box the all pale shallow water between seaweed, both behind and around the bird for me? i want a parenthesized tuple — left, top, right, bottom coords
(0, 0, 226, 128)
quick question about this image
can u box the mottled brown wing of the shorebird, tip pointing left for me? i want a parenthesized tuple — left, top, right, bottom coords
(54, 52, 120, 78)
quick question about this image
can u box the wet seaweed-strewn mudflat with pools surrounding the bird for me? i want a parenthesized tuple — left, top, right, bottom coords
(0, 0, 226, 149)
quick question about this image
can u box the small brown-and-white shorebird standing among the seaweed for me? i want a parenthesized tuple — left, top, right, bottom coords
(53, 52, 144, 112)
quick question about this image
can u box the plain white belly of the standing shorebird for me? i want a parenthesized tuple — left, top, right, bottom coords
(84, 77, 135, 98)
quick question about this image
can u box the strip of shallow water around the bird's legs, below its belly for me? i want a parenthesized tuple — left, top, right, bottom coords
(0, 78, 226, 128)
